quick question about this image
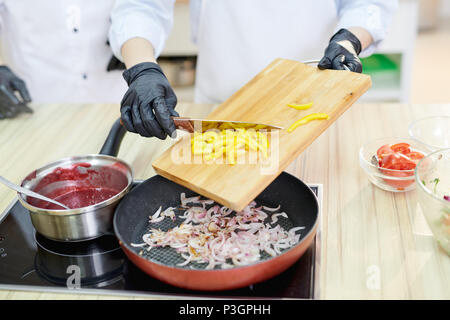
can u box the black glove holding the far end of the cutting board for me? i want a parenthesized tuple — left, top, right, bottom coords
(318, 29, 362, 73)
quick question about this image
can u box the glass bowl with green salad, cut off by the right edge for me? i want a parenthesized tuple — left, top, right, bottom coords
(415, 148, 450, 255)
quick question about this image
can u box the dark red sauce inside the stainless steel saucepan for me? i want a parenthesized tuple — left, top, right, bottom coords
(27, 163, 128, 210)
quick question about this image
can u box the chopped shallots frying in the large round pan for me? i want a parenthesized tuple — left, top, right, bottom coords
(132, 193, 304, 269)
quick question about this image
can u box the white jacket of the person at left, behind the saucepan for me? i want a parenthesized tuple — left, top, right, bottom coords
(0, 0, 127, 103)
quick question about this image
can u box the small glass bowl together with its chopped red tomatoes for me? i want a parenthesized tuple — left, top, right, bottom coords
(359, 138, 429, 192)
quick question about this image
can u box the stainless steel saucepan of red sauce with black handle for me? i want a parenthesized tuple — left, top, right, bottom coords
(18, 120, 133, 241)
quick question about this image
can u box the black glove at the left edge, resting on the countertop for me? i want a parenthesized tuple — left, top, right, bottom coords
(0, 66, 33, 119)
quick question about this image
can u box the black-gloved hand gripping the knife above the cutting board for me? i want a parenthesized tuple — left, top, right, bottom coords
(120, 62, 179, 139)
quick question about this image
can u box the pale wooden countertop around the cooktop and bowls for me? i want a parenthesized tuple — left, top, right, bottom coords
(0, 104, 450, 299)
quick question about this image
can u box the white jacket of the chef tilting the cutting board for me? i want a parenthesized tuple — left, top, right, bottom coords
(109, 0, 398, 103)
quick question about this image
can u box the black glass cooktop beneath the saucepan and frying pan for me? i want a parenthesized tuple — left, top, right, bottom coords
(0, 186, 319, 299)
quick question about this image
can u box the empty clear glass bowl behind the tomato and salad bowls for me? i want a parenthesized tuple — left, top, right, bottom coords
(408, 116, 450, 151)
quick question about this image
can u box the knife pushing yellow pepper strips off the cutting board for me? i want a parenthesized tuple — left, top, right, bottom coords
(172, 117, 283, 133)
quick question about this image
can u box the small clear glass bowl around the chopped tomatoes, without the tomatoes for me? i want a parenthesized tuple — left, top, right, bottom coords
(359, 138, 429, 192)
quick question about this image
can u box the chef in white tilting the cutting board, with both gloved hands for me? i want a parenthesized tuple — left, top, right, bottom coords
(109, 0, 397, 139)
